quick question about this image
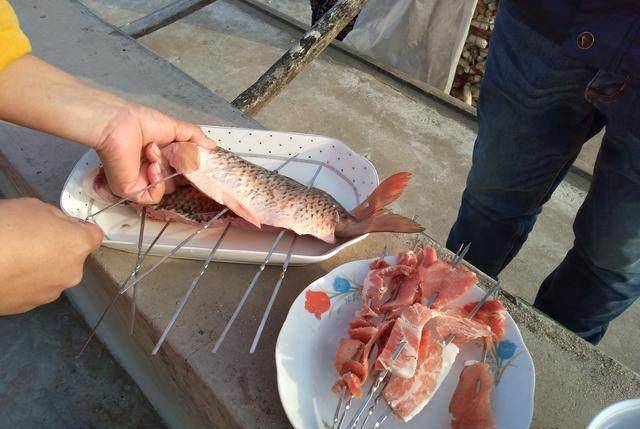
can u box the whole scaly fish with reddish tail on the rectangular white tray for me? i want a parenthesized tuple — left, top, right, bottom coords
(83, 143, 424, 243)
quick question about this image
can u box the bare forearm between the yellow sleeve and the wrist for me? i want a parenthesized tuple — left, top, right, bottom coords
(0, 55, 128, 147)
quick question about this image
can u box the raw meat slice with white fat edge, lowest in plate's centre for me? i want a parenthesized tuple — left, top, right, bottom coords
(383, 328, 459, 422)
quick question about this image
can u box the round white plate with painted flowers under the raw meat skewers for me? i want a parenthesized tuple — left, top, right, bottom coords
(276, 258, 535, 429)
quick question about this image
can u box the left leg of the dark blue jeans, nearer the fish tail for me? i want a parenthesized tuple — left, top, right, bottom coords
(447, 2, 602, 277)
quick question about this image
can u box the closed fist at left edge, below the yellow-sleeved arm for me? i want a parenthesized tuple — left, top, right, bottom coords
(0, 198, 103, 315)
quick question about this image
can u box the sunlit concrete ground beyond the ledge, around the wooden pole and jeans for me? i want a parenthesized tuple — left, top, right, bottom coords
(85, 0, 640, 371)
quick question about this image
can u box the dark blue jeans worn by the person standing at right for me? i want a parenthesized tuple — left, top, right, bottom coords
(447, 1, 640, 344)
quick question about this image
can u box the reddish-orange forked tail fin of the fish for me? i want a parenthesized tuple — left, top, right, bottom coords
(336, 173, 424, 237)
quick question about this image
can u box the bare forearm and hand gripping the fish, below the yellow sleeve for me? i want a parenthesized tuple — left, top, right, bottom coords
(0, 55, 215, 204)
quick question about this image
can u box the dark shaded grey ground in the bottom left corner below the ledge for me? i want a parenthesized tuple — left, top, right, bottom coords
(0, 297, 165, 429)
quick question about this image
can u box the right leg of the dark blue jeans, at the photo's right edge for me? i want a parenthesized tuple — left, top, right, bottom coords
(535, 72, 640, 344)
